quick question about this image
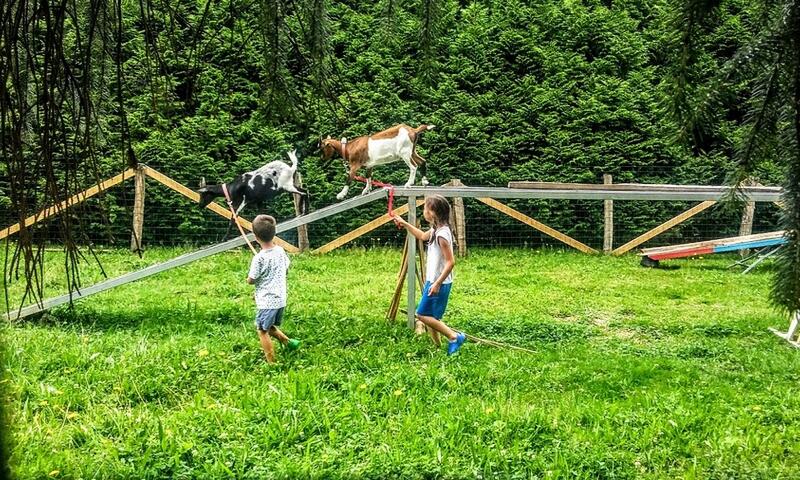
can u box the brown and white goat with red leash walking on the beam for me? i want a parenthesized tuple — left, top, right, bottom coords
(319, 124, 434, 200)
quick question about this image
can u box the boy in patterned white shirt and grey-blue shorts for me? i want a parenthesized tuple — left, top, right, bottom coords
(247, 215, 300, 363)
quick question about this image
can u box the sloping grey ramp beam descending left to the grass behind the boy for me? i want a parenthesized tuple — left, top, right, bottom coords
(5, 189, 387, 321)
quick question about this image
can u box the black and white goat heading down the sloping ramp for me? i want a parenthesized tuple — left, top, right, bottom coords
(197, 150, 308, 220)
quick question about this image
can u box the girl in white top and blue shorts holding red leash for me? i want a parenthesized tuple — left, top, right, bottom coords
(392, 195, 467, 355)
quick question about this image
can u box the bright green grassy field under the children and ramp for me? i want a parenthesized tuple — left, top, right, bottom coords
(2, 249, 800, 479)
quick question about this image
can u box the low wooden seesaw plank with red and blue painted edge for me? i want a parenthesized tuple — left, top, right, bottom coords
(639, 230, 786, 266)
